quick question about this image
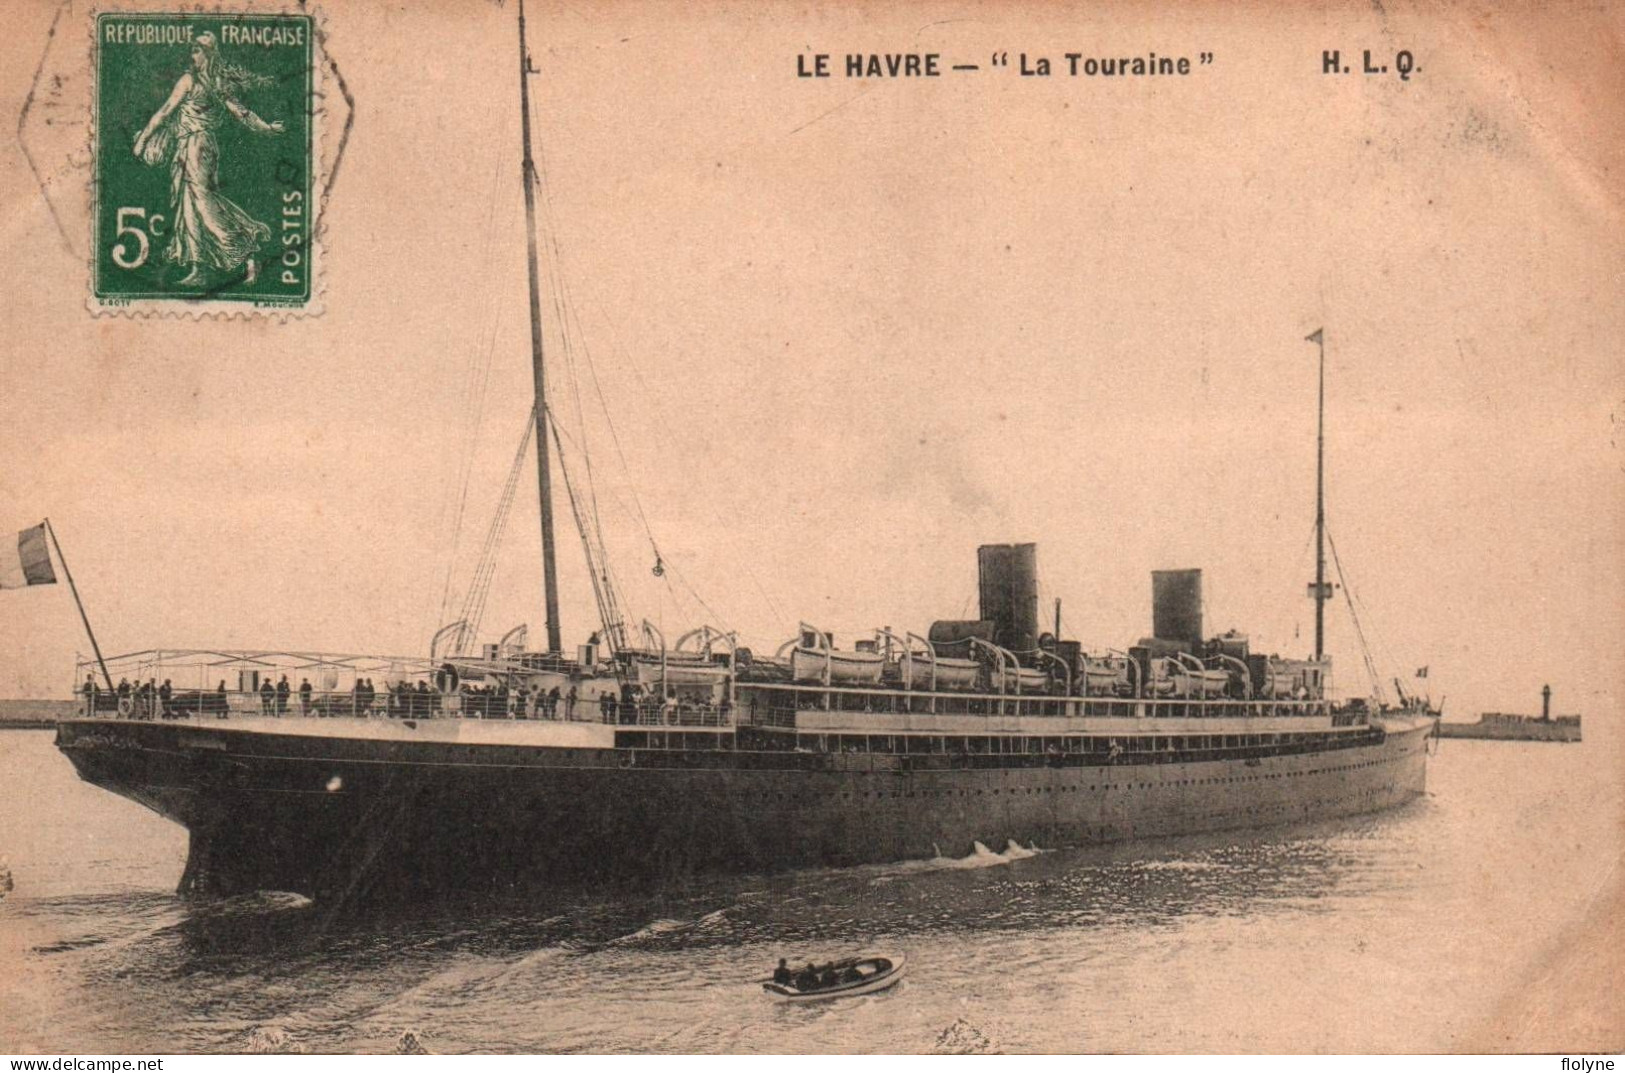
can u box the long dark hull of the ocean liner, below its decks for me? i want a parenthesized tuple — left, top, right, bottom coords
(57, 720, 1432, 901)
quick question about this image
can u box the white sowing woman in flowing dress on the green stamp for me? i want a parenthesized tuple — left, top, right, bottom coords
(135, 33, 283, 285)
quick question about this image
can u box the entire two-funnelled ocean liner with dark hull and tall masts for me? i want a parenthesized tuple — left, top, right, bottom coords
(57, 5, 1435, 902)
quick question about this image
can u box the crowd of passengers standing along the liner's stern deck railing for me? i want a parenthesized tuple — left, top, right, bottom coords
(81, 675, 733, 725)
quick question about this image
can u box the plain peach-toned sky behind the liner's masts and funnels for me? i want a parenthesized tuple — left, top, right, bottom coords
(0, 0, 1625, 1050)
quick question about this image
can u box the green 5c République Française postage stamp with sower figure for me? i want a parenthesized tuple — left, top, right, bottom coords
(91, 11, 319, 312)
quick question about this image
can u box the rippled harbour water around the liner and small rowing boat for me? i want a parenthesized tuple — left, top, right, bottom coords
(0, 720, 1625, 1053)
